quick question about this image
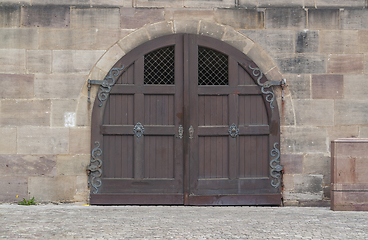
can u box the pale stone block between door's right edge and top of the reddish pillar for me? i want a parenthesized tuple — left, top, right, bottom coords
(281, 127, 328, 154)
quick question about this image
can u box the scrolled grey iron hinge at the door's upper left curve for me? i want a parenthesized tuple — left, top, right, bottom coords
(87, 65, 124, 107)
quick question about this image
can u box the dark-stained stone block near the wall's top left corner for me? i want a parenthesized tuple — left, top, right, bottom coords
(22, 5, 70, 28)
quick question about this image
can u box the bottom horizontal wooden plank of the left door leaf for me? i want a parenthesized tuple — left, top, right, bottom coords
(90, 194, 183, 205)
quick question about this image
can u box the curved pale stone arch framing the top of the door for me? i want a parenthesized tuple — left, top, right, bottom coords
(77, 20, 282, 125)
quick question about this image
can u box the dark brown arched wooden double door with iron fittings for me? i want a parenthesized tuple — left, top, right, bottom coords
(90, 34, 281, 205)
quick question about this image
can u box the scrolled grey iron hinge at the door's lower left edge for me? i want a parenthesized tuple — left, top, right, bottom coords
(87, 141, 102, 194)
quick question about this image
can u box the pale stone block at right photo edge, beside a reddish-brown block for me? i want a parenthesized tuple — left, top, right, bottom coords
(344, 75, 368, 100)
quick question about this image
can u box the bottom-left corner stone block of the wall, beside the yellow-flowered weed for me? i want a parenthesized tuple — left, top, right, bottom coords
(0, 177, 28, 202)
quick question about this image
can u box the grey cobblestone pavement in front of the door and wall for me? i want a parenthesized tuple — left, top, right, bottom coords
(0, 204, 368, 239)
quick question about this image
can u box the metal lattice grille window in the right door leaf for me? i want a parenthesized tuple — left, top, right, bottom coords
(198, 47, 229, 85)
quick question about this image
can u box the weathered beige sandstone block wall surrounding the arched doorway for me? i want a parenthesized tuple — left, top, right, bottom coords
(0, 0, 368, 205)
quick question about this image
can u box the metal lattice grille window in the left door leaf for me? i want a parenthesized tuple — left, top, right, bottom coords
(144, 46, 175, 84)
